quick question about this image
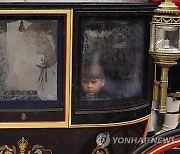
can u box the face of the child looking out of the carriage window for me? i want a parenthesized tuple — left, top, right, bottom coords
(81, 79, 105, 96)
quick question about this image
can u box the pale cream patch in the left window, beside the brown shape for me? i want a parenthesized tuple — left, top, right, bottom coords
(6, 20, 39, 91)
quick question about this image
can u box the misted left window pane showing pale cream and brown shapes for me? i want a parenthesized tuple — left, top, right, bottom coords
(0, 20, 57, 101)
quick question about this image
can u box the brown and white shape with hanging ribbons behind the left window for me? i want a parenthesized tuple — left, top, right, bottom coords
(23, 20, 57, 100)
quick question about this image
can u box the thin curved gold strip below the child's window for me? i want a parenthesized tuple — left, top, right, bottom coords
(70, 115, 151, 128)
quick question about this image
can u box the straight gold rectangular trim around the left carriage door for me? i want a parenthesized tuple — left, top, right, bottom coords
(0, 9, 73, 129)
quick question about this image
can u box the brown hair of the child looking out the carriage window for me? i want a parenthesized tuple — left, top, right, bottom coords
(81, 64, 105, 79)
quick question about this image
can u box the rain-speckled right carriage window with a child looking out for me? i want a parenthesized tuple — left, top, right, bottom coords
(76, 17, 147, 110)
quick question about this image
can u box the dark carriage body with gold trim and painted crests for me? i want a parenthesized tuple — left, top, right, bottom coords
(0, 0, 157, 154)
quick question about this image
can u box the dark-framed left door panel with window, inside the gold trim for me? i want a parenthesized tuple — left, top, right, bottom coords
(0, 14, 66, 121)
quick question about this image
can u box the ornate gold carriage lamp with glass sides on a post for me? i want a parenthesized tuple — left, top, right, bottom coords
(150, 0, 180, 114)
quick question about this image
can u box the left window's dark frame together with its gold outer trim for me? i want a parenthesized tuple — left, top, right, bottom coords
(0, 9, 72, 128)
